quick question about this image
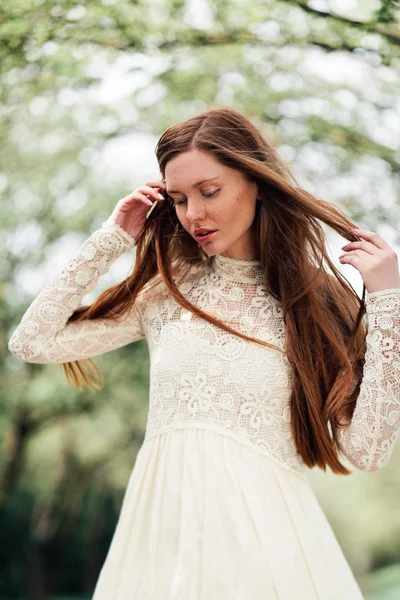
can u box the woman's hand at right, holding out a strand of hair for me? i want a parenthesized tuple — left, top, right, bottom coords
(339, 229, 400, 293)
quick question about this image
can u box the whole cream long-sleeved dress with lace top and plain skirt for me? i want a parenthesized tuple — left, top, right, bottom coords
(9, 218, 400, 600)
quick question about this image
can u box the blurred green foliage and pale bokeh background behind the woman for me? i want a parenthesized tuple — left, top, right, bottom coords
(0, 0, 400, 600)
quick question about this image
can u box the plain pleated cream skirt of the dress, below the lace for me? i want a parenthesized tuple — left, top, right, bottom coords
(93, 427, 363, 600)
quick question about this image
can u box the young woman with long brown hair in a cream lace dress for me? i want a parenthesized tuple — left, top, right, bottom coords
(9, 107, 400, 600)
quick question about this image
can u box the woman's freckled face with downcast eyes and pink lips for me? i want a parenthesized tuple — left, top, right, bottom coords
(165, 150, 258, 260)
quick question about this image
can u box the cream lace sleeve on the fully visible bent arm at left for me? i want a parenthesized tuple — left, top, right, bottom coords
(8, 217, 145, 364)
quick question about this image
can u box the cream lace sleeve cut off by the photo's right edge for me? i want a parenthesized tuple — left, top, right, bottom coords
(338, 288, 400, 471)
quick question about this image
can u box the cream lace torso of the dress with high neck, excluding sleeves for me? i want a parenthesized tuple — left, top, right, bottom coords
(142, 256, 303, 471)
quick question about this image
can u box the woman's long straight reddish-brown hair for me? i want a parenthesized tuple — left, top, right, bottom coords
(62, 107, 367, 474)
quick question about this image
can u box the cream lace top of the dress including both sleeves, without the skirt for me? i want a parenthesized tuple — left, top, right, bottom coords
(9, 218, 400, 474)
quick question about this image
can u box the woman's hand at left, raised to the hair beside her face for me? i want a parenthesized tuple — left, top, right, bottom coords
(111, 180, 165, 240)
